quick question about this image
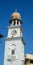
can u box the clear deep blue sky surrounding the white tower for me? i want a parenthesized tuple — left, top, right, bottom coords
(0, 0, 33, 65)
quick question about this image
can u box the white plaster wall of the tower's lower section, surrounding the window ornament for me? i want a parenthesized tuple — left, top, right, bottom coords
(4, 40, 24, 65)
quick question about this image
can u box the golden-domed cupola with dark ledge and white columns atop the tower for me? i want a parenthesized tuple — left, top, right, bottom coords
(9, 11, 22, 26)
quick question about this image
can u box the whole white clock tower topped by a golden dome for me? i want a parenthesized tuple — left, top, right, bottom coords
(4, 12, 25, 65)
